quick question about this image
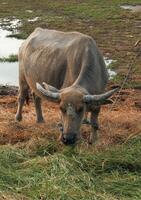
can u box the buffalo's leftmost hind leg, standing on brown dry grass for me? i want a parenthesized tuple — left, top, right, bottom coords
(15, 83, 29, 121)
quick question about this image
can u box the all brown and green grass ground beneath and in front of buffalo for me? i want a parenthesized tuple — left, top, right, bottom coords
(0, 90, 141, 200)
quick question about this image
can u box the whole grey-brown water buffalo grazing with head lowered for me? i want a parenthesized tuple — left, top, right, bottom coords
(16, 28, 117, 145)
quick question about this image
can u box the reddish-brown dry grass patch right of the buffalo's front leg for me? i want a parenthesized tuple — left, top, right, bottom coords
(101, 90, 141, 147)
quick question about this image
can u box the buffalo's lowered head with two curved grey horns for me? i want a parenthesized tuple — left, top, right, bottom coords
(36, 83, 117, 145)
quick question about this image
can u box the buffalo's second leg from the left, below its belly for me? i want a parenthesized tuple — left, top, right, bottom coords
(33, 93, 44, 123)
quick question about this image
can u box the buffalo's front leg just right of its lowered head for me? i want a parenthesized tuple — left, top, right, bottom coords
(89, 107, 100, 144)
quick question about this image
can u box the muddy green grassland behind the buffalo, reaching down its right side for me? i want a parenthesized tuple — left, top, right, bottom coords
(0, 0, 141, 87)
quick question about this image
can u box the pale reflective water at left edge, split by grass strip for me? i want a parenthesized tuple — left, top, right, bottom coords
(0, 18, 24, 86)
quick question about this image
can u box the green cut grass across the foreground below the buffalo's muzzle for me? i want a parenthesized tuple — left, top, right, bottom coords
(0, 136, 141, 200)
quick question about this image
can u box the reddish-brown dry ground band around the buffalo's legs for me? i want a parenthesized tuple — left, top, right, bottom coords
(0, 86, 141, 147)
